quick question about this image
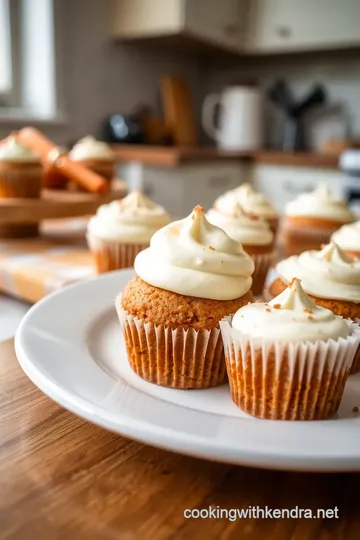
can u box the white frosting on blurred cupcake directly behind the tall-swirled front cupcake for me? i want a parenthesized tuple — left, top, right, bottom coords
(207, 199, 274, 246)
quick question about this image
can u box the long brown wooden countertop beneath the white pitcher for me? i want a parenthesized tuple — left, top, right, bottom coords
(113, 144, 339, 169)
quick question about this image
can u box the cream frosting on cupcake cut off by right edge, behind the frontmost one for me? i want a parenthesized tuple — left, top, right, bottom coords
(276, 242, 360, 303)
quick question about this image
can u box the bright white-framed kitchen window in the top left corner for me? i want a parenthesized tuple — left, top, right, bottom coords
(0, 0, 59, 121)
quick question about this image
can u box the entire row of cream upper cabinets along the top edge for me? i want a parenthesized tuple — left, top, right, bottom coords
(112, 0, 360, 54)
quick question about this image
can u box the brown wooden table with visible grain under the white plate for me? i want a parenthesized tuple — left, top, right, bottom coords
(0, 341, 360, 540)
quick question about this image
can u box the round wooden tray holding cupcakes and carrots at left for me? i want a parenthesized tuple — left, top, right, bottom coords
(0, 182, 126, 226)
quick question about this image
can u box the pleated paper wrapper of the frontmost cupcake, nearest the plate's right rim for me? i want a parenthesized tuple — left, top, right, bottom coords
(220, 318, 360, 420)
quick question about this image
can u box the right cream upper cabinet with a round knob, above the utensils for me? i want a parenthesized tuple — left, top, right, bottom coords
(246, 0, 360, 53)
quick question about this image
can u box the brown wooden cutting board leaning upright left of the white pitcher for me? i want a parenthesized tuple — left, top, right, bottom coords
(161, 75, 199, 146)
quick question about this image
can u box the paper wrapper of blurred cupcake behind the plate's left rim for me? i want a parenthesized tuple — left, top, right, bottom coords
(87, 235, 149, 274)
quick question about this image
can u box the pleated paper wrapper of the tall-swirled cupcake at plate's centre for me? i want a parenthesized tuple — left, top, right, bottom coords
(115, 295, 227, 389)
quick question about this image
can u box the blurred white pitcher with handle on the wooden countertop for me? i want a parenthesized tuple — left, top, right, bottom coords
(202, 86, 263, 151)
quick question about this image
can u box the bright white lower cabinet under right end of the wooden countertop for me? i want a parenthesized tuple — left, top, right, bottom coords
(251, 165, 344, 212)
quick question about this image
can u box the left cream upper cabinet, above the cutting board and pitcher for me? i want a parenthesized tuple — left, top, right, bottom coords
(112, 0, 249, 51)
